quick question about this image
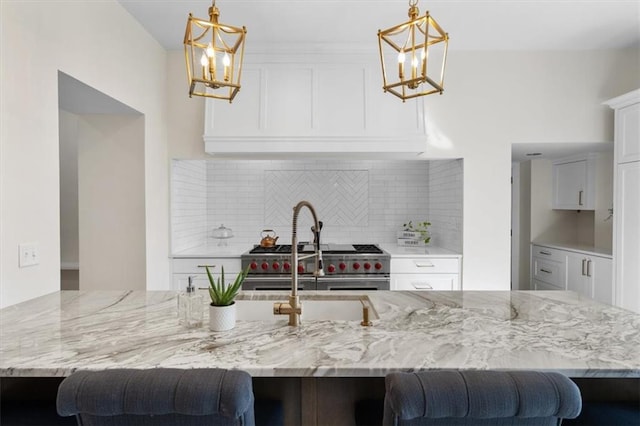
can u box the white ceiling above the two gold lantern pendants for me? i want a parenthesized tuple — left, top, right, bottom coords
(118, 0, 640, 52)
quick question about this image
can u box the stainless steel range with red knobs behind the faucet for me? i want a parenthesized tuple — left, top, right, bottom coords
(241, 244, 391, 290)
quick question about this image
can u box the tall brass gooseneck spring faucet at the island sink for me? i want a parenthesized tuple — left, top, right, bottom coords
(273, 201, 324, 326)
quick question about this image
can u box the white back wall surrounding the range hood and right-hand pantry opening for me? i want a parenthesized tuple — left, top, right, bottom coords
(168, 50, 640, 290)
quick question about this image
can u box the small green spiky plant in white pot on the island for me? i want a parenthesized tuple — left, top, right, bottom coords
(205, 266, 249, 331)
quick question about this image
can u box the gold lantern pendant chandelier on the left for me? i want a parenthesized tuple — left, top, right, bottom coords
(184, 0, 247, 103)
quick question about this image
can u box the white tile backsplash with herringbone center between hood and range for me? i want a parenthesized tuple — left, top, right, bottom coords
(171, 160, 463, 252)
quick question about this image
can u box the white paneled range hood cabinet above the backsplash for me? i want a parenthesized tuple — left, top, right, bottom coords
(204, 55, 426, 153)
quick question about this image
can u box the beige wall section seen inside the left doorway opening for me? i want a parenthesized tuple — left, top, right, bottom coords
(78, 115, 146, 290)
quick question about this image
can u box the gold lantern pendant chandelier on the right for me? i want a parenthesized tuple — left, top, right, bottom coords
(378, 0, 449, 102)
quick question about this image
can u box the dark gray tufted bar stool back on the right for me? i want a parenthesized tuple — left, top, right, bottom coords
(383, 370, 582, 426)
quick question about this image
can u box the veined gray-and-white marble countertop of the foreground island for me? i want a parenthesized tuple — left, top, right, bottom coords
(0, 291, 640, 377)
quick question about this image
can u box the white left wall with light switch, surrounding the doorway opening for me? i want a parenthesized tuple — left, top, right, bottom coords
(0, 0, 169, 306)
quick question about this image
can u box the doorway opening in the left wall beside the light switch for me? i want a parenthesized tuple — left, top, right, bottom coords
(58, 72, 146, 290)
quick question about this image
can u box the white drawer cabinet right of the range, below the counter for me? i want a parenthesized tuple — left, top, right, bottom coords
(391, 257, 460, 290)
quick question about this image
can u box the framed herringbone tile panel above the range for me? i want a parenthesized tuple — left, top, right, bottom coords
(264, 170, 369, 227)
